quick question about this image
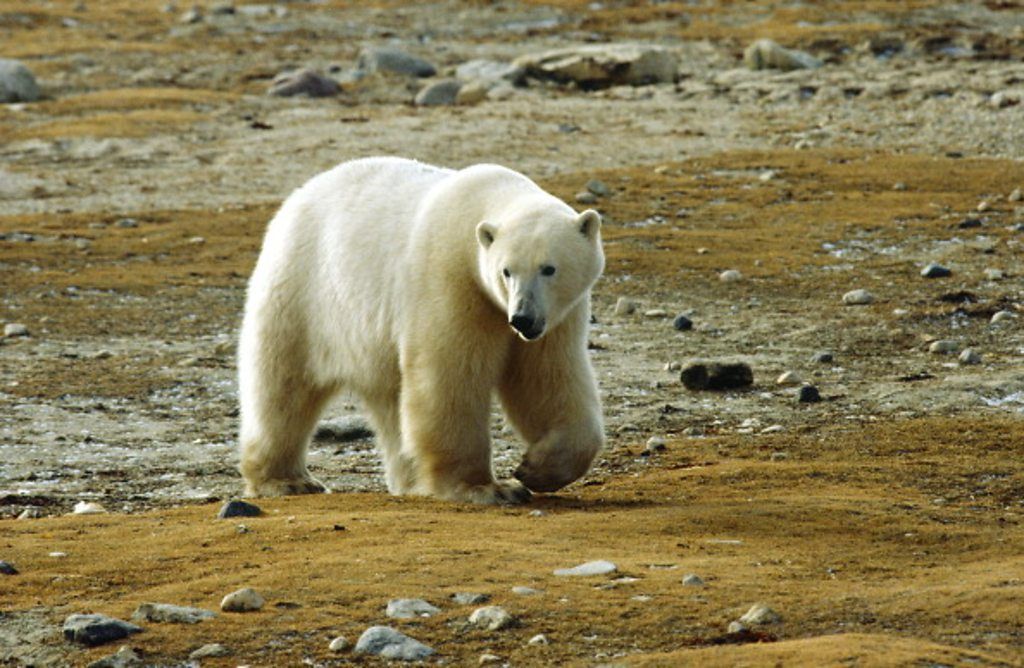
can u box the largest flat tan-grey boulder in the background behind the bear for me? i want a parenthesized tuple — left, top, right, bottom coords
(515, 44, 679, 89)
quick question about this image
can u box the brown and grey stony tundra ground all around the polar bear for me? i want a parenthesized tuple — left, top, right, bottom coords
(0, 0, 1024, 665)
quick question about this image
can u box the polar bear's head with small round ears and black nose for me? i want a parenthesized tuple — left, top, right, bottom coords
(476, 198, 604, 341)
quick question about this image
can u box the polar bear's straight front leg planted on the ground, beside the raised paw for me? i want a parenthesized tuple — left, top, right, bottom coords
(401, 346, 530, 504)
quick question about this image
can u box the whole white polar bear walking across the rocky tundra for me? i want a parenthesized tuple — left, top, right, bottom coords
(239, 158, 604, 503)
